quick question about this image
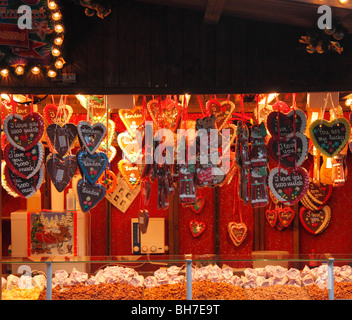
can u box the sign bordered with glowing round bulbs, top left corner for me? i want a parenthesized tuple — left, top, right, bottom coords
(0, 0, 65, 79)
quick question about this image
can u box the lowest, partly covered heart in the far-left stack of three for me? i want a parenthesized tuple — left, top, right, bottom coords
(4, 165, 44, 198)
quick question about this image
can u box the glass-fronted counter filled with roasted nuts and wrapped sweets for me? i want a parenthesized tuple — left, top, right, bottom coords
(2, 252, 352, 300)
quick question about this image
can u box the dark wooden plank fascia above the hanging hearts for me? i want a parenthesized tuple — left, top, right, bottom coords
(0, 1, 352, 94)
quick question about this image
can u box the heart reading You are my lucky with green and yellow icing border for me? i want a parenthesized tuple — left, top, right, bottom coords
(309, 117, 351, 158)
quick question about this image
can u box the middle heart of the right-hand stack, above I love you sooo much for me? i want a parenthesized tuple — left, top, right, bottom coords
(268, 132, 309, 168)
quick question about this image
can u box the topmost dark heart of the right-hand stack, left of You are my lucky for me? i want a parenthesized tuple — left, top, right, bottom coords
(266, 109, 307, 137)
